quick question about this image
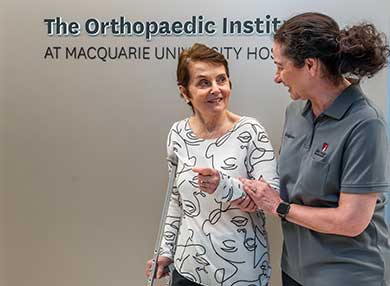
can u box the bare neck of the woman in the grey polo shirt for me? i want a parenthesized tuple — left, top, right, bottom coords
(309, 78, 351, 117)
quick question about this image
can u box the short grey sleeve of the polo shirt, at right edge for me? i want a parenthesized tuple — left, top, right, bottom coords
(340, 119, 389, 193)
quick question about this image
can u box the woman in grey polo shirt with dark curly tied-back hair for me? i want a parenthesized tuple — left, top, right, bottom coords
(242, 13, 390, 286)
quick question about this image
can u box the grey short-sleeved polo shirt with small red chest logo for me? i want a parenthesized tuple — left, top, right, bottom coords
(278, 85, 390, 286)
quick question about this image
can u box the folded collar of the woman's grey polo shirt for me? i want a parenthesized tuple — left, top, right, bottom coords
(302, 84, 364, 120)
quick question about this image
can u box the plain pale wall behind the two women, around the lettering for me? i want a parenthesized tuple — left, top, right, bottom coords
(0, 0, 389, 286)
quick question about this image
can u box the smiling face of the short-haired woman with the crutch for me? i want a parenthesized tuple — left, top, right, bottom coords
(179, 61, 231, 117)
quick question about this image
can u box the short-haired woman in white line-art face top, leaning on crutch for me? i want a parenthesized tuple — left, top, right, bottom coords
(146, 44, 279, 286)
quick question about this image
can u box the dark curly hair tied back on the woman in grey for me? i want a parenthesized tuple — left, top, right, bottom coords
(274, 12, 389, 82)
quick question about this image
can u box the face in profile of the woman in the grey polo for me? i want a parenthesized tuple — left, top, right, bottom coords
(272, 42, 310, 100)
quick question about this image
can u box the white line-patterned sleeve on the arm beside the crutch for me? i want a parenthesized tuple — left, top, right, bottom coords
(159, 126, 183, 260)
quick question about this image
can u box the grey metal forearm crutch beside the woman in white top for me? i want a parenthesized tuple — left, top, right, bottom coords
(148, 154, 178, 286)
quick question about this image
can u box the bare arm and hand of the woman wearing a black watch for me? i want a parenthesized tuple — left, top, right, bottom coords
(241, 179, 378, 237)
